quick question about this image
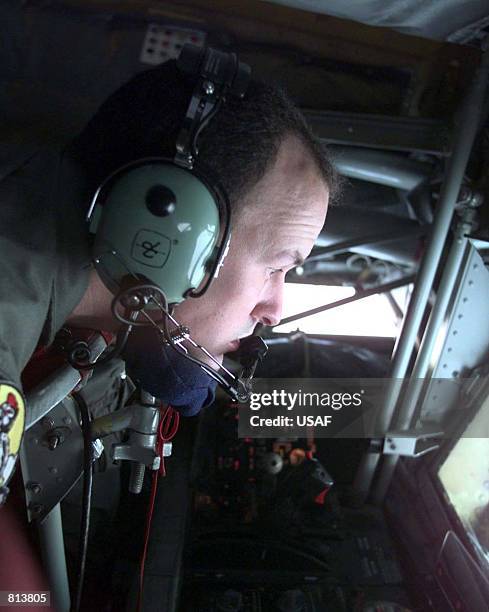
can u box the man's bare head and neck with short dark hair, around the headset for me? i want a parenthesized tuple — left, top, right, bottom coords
(68, 62, 336, 388)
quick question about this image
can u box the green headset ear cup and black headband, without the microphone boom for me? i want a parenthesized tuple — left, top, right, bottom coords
(88, 45, 250, 304)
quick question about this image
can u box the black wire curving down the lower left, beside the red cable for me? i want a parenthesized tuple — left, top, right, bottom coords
(71, 393, 93, 612)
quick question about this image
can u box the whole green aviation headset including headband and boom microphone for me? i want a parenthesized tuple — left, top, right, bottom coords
(78, 45, 267, 401)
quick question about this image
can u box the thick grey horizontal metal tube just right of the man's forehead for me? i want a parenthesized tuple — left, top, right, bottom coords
(329, 145, 432, 191)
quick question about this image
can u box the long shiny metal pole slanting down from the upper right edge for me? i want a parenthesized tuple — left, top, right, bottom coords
(354, 41, 489, 503)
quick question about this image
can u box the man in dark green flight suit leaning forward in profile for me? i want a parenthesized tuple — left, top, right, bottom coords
(0, 53, 336, 498)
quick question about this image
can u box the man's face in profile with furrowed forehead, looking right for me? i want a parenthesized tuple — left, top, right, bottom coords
(174, 137, 328, 359)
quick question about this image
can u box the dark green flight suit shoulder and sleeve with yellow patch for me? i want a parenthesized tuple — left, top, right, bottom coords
(0, 150, 90, 502)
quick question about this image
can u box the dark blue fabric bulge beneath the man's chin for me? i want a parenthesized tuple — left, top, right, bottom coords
(123, 328, 217, 416)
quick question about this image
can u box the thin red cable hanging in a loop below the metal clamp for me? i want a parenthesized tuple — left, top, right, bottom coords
(136, 406, 180, 612)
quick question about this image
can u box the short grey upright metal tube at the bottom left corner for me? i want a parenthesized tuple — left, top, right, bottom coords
(38, 504, 71, 612)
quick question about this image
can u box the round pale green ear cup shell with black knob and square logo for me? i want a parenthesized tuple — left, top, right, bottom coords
(91, 158, 226, 303)
